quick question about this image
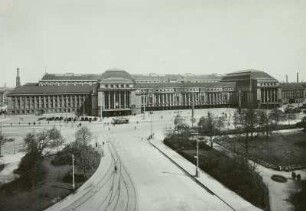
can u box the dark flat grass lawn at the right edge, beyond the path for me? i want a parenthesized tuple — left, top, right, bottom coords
(215, 132, 306, 166)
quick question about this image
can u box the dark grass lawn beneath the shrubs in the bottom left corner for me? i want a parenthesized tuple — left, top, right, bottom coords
(0, 157, 81, 211)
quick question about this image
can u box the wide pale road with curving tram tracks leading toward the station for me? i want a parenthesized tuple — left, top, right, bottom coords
(44, 110, 231, 211)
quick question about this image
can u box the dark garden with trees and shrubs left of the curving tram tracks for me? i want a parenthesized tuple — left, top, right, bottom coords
(0, 127, 101, 210)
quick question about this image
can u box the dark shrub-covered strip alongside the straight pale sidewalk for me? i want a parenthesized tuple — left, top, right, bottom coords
(164, 135, 269, 210)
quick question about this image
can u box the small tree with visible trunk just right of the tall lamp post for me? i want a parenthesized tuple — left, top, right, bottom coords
(198, 112, 223, 148)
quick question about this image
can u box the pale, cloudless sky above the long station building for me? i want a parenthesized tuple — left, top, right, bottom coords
(0, 0, 306, 87)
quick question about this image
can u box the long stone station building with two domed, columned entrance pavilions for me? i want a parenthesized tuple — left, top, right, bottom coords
(8, 69, 306, 117)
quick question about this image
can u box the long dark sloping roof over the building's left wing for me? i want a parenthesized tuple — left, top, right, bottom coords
(9, 85, 97, 96)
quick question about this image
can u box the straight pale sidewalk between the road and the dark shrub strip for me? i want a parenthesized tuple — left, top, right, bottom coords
(150, 134, 261, 211)
